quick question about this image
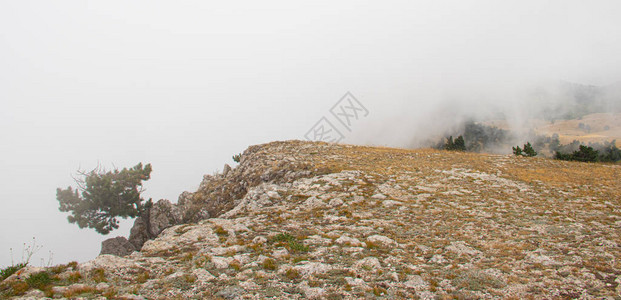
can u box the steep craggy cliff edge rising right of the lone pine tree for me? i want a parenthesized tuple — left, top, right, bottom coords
(102, 142, 342, 254)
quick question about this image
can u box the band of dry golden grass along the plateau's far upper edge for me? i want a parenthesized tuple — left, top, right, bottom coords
(306, 141, 621, 199)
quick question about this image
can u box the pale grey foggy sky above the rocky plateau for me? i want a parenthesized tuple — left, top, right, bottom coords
(0, 0, 621, 265)
